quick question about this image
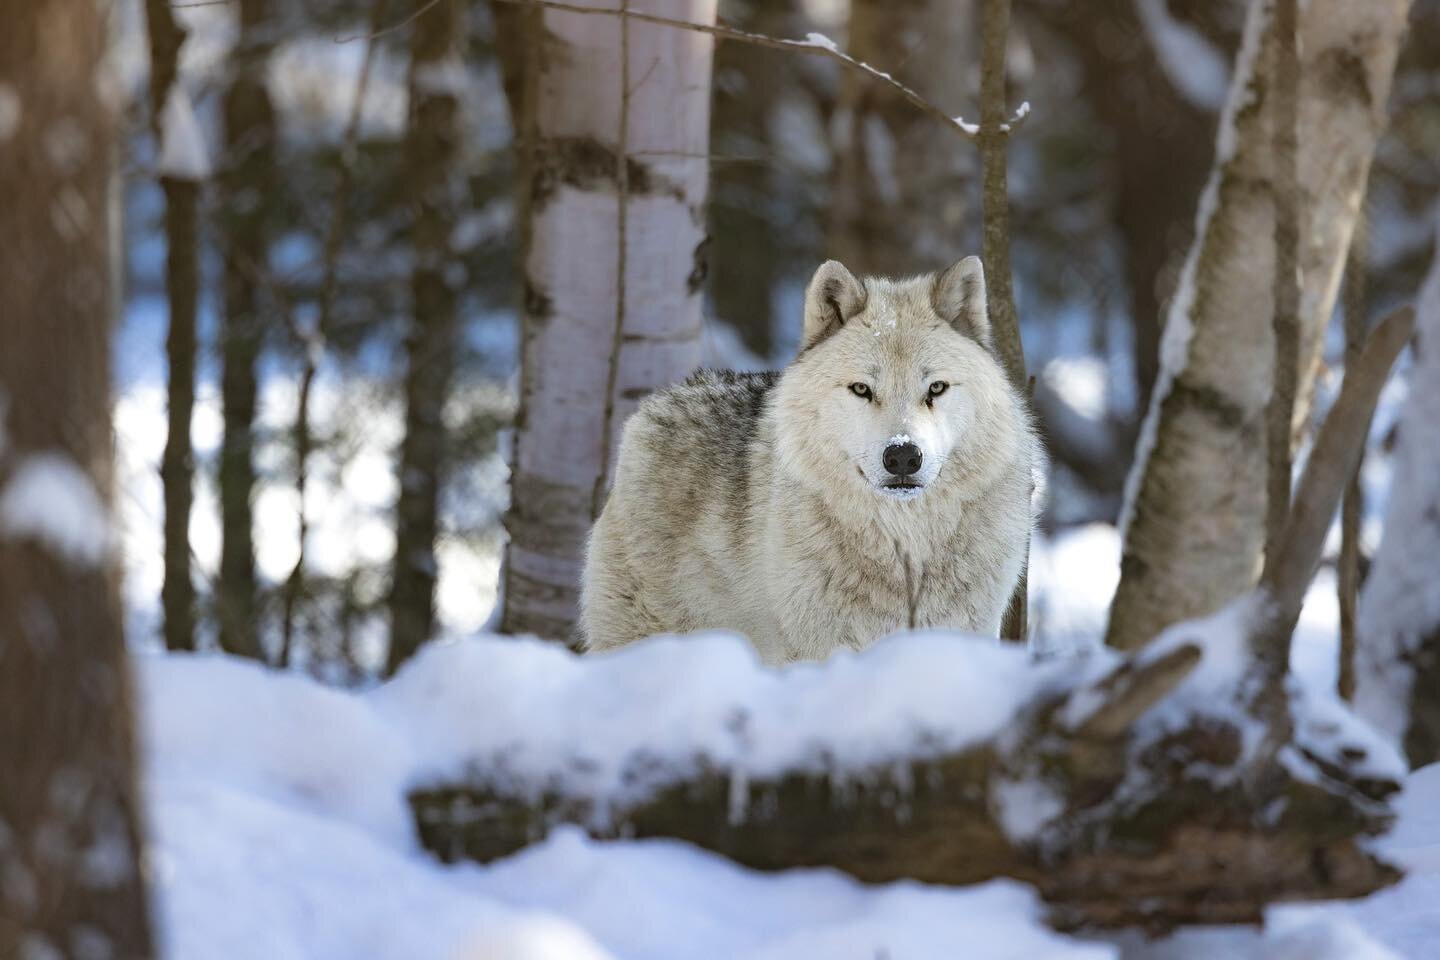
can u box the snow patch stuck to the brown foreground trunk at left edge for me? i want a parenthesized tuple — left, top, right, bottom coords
(0, 452, 112, 566)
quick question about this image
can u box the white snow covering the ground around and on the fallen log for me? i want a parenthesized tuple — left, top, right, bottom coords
(135, 624, 1440, 960)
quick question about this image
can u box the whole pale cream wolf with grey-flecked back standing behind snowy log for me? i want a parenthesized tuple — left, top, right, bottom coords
(580, 256, 1044, 664)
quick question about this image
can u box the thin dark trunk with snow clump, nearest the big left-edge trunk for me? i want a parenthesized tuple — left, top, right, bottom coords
(145, 0, 200, 651)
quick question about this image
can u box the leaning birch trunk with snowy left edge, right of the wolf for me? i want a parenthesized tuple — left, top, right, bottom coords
(1106, 0, 1410, 649)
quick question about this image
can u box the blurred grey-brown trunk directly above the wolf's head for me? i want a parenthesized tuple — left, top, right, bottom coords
(829, 0, 973, 277)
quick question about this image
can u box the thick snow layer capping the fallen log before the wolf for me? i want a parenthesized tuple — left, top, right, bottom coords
(374, 633, 1073, 802)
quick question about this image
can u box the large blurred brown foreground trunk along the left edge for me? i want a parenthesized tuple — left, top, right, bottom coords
(0, 0, 153, 959)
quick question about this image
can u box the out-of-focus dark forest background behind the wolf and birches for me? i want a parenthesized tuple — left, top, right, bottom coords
(115, 0, 1440, 682)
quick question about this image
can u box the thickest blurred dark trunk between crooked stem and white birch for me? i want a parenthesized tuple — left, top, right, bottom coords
(389, 0, 465, 672)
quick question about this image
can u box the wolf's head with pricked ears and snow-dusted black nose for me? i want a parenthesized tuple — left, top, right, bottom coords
(779, 256, 1024, 501)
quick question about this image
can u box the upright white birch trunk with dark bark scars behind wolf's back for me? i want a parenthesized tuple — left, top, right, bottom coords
(501, 0, 716, 639)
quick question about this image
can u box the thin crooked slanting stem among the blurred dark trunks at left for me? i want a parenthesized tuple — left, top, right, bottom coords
(279, 0, 391, 668)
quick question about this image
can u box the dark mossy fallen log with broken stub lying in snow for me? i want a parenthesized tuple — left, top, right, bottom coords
(410, 643, 1398, 931)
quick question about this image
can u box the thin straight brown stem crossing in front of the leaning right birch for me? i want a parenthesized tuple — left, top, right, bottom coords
(1266, 0, 1300, 578)
